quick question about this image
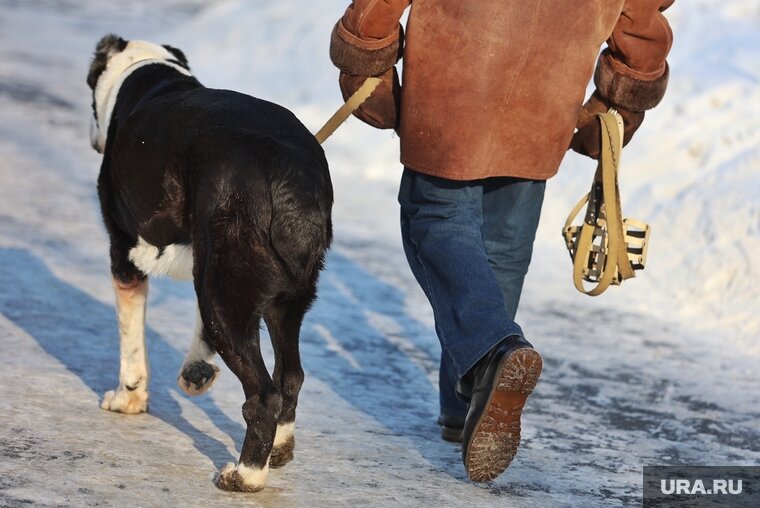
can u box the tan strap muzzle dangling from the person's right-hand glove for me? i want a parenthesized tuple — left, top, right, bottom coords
(562, 109, 650, 296)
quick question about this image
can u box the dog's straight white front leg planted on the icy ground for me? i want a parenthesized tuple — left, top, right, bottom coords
(100, 277, 148, 414)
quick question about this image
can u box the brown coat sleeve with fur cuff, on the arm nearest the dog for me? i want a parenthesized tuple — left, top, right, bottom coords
(330, 0, 411, 76)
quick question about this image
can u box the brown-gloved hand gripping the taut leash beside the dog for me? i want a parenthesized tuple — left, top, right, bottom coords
(339, 66, 401, 129)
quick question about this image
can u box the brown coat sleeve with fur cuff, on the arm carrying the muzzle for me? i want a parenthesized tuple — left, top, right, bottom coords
(594, 0, 674, 112)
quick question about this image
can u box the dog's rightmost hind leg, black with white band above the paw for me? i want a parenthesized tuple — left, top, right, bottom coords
(266, 293, 314, 467)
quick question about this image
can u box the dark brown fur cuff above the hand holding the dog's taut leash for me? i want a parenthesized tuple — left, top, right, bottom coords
(330, 21, 403, 76)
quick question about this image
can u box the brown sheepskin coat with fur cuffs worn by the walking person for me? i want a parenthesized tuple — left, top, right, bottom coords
(331, 0, 674, 180)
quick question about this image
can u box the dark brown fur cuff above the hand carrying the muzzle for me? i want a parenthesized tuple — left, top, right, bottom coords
(594, 50, 670, 112)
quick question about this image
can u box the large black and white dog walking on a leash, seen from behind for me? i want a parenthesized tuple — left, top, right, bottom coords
(87, 35, 333, 491)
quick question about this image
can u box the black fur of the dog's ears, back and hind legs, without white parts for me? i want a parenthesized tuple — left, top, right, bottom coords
(88, 36, 333, 488)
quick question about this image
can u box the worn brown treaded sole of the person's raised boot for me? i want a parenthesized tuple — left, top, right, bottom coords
(465, 348, 543, 482)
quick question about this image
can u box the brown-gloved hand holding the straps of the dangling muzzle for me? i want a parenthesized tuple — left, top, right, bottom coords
(569, 92, 644, 159)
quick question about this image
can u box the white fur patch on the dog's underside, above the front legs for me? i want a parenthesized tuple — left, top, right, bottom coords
(129, 237, 193, 280)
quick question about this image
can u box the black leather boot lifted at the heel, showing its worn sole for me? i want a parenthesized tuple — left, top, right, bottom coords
(460, 335, 542, 482)
